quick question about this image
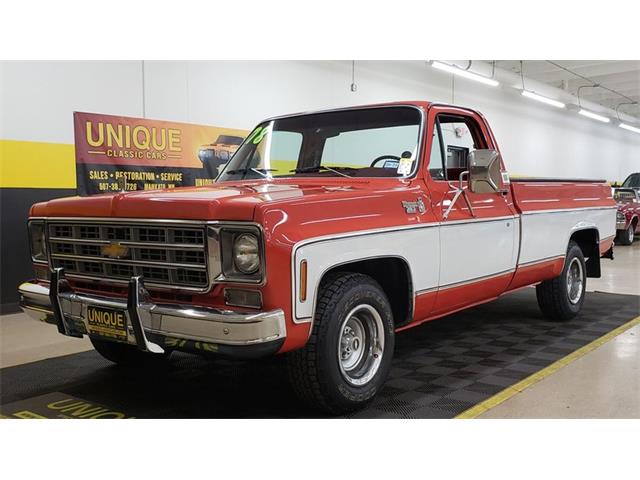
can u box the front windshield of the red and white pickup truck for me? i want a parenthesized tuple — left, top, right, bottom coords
(217, 107, 422, 182)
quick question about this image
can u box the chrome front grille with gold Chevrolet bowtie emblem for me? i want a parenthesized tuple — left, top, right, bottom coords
(47, 221, 209, 290)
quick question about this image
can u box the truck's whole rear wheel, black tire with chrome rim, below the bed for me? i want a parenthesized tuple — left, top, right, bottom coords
(536, 241, 587, 322)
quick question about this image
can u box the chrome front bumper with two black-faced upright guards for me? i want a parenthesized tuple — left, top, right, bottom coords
(18, 268, 286, 357)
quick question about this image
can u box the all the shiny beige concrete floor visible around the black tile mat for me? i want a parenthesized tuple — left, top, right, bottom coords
(0, 238, 640, 418)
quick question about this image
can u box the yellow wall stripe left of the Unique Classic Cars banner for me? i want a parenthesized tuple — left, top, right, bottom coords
(0, 140, 76, 188)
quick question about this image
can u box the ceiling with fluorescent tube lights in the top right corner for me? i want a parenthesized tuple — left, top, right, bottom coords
(497, 60, 640, 117)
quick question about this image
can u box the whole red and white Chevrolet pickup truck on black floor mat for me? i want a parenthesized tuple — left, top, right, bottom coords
(19, 102, 616, 413)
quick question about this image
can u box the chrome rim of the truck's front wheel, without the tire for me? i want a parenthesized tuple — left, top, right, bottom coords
(338, 304, 384, 386)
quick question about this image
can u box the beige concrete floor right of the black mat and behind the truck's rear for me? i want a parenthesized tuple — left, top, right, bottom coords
(479, 242, 640, 418)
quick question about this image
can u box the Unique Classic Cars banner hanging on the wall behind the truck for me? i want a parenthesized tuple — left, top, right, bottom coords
(73, 112, 248, 195)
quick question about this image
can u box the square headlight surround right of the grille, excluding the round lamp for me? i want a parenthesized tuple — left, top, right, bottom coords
(220, 225, 265, 284)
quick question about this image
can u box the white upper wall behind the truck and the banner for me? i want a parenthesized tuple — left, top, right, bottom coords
(0, 61, 640, 180)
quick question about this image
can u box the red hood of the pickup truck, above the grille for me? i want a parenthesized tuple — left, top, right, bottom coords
(30, 179, 378, 221)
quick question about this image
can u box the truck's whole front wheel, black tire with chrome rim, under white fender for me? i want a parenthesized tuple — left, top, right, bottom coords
(288, 273, 395, 414)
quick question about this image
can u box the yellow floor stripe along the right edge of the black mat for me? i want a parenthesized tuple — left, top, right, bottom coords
(455, 317, 640, 418)
